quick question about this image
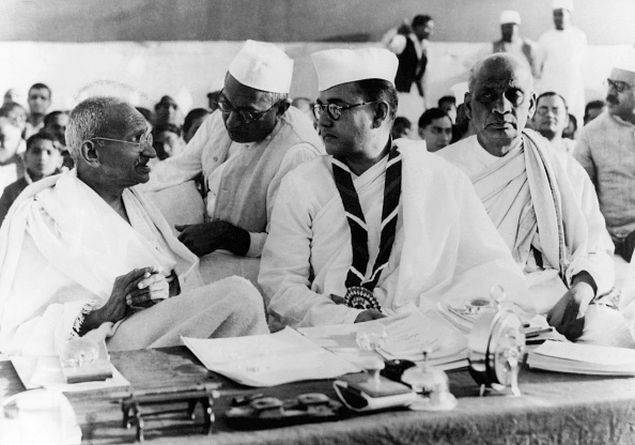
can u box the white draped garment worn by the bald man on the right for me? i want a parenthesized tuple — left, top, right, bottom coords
(439, 132, 615, 312)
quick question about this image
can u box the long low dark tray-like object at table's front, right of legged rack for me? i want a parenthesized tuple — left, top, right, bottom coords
(225, 393, 342, 429)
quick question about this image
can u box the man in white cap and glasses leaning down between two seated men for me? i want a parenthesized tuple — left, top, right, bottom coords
(140, 40, 324, 281)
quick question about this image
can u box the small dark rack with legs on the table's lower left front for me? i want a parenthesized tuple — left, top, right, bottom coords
(116, 383, 220, 442)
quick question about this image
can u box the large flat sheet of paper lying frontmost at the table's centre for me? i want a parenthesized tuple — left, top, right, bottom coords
(181, 327, 361, 387)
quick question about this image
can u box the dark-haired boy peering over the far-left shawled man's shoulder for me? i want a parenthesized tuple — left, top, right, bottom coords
(0, 130, 63, 224)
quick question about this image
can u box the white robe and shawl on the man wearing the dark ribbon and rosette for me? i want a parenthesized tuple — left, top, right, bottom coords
(259, 140, 526, 326)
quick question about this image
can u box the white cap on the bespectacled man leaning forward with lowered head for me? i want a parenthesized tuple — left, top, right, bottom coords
(228, 40, 293, 93)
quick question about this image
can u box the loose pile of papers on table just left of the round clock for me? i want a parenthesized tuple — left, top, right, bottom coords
(299, 309, 468, 370)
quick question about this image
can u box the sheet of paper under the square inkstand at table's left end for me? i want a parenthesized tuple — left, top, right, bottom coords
(11, 356, 130, 392)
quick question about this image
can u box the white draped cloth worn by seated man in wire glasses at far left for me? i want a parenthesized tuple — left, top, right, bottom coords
(0, 171, 265, 355)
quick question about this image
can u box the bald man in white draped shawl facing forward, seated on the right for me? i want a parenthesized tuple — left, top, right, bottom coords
(439, 54, 633, 346)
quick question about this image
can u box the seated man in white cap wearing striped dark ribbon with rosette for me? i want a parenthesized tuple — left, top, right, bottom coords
(259, 48, 524, 326)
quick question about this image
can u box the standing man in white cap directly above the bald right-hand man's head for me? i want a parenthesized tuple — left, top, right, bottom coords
(492, 9, 540, 77)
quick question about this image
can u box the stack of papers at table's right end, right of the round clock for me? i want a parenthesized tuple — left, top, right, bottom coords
(527, 340, 635, 376)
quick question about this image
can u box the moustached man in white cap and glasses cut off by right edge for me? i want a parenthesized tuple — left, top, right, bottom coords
(575, 68, 635, 261)
